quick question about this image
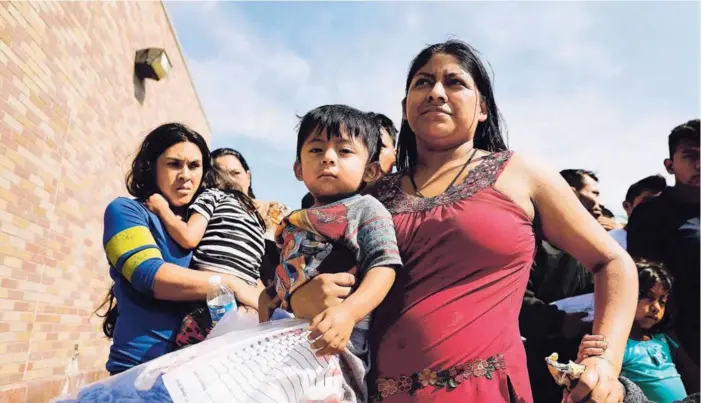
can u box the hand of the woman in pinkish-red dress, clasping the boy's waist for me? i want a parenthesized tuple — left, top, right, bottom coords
(290, 273, 355, 320)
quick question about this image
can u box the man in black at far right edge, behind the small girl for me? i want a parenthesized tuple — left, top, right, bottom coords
(628, 119, 701, 386)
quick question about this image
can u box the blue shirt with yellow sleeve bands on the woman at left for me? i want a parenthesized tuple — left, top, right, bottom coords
(103, 197, 192, 373)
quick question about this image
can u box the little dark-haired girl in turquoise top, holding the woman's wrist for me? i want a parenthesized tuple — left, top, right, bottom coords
(577, 260, 690, 403)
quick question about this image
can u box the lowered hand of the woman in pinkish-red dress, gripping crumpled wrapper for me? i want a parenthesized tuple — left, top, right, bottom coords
(563, 356, 624, 403)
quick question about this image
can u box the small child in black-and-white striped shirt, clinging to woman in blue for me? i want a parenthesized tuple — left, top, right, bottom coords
(146, 164, 265, 348)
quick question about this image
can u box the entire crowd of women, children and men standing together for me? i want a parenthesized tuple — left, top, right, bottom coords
(95, 40, 700, 403)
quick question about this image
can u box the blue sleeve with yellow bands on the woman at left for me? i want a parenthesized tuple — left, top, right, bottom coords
(102, 197, 163, 295)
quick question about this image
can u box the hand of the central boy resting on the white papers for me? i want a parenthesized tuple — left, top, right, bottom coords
(309, 305, 355, 356)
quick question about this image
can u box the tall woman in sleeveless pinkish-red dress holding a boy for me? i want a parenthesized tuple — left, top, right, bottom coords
(292, 41, 637, 403)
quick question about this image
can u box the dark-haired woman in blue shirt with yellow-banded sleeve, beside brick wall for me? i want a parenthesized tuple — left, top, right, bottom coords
(98, 123, 243, 374)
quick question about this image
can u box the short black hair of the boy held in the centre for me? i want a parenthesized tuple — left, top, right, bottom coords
(297, 105, 380, 162)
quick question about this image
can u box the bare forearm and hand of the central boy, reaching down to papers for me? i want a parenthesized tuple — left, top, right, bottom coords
(309, 266, 396, 356)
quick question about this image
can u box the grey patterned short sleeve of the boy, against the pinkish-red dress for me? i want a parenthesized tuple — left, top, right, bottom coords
(346, 196, 402, 273)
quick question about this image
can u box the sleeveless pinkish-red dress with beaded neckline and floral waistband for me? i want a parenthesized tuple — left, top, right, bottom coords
(373, 151, 535, 403)
